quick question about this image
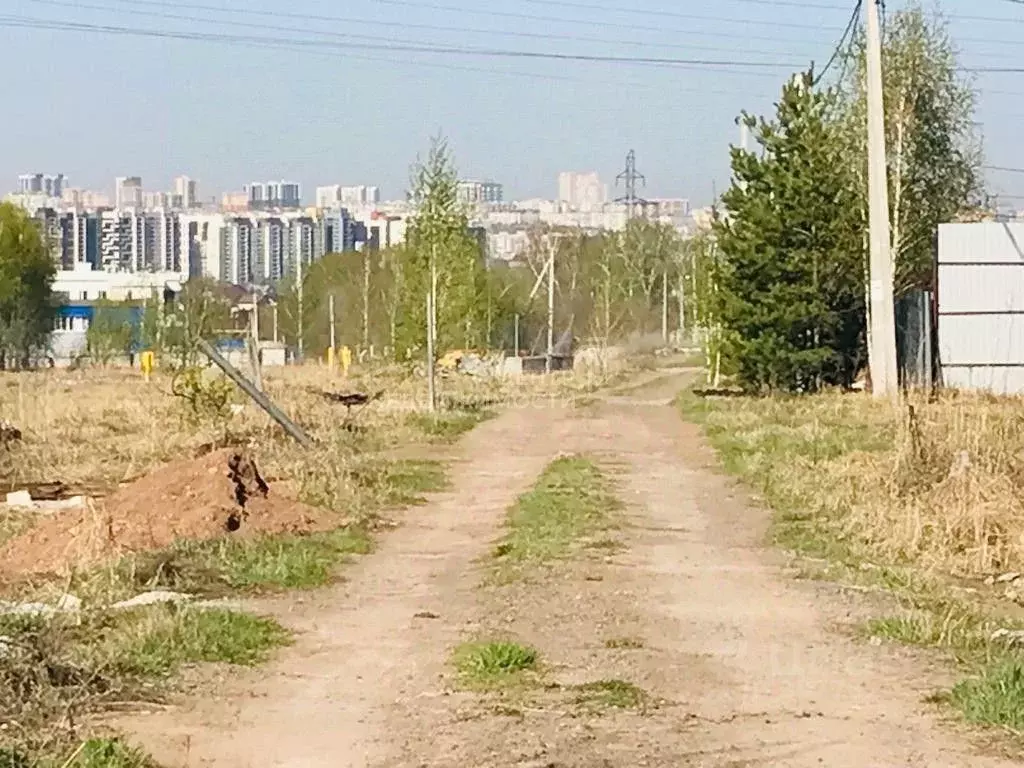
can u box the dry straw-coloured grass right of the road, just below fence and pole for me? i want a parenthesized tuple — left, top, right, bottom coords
(684, 394, 1024, 577)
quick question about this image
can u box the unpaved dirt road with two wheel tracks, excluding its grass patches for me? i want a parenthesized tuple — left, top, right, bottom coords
(120, 380, 1016, 768)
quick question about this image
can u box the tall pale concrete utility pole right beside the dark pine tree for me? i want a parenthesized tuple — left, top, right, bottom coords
(864, 0, 899, 399)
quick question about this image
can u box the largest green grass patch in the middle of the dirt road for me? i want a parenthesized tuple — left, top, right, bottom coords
(495, 456, 622, 577)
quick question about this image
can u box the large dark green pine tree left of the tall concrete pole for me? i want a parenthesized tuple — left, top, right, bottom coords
(714, 75, 864, 392)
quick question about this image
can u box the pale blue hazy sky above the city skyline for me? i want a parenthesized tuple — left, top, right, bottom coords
(0, 0, 1024, 204)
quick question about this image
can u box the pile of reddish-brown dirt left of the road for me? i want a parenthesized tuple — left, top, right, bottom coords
(0, 450, 341, 579)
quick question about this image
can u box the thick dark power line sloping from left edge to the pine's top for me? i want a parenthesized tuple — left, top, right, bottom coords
(0, 16, 800, 72)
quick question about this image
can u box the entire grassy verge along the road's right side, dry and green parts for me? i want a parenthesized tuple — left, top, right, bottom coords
(679, 394, 1024, 738)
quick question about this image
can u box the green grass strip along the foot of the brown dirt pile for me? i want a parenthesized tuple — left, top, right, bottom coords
(115, 527, 373, 595)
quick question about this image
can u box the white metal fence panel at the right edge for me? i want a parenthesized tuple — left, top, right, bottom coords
(938, 222, 1024, 393)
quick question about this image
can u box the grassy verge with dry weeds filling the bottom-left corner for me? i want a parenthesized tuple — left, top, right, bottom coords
(0, 606, 290, 767)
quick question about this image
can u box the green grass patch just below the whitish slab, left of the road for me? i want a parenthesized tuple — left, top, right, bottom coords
(109, 606, 291, 677)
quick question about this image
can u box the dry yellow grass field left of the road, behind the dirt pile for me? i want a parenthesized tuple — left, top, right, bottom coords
(0, 365, 614, 501)
